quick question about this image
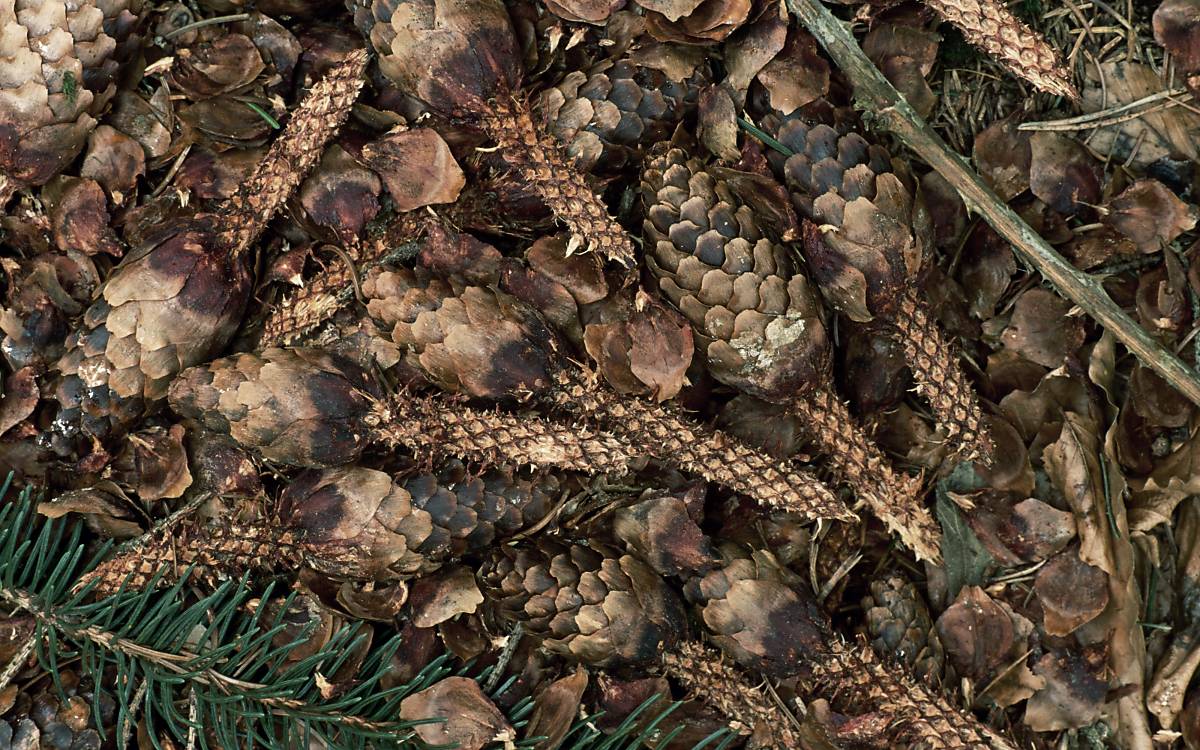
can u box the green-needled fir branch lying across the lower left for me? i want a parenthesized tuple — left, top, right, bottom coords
(0, 475, 682, 750)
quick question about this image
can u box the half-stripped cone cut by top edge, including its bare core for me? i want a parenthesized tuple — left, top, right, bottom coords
(348, 0, 634, 266)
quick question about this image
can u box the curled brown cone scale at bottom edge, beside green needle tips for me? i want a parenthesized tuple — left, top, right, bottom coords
(400, 677, 516, 750)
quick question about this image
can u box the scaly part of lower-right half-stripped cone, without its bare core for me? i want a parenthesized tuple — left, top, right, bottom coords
(684, 544, 826, 677)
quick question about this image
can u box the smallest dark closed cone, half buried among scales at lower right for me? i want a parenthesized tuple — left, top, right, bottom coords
(863, 576, 946, 688)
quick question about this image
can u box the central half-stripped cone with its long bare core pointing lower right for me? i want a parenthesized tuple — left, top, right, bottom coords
(362, 270, 851, 518)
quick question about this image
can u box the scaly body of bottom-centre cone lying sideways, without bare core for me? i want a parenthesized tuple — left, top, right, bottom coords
(479, 540, 685, 667)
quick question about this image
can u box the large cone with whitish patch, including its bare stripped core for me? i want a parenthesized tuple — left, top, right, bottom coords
(642, 149, 940, 559)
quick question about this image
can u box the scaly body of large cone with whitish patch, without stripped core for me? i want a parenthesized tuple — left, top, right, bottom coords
(642, 149, 830, 402)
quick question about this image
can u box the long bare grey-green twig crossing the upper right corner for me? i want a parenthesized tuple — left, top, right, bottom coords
(787, 0, 1200, 404)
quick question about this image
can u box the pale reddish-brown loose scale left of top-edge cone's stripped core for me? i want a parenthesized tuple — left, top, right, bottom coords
(362, 127, 467, 211)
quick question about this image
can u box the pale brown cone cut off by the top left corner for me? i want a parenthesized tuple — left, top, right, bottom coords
(0, 0, 143, 199)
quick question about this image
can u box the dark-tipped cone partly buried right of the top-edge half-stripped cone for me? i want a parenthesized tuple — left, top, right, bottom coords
(538, 58, 704, 173)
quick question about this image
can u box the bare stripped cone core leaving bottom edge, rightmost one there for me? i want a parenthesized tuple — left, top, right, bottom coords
(809, 637, 1016, 750)
